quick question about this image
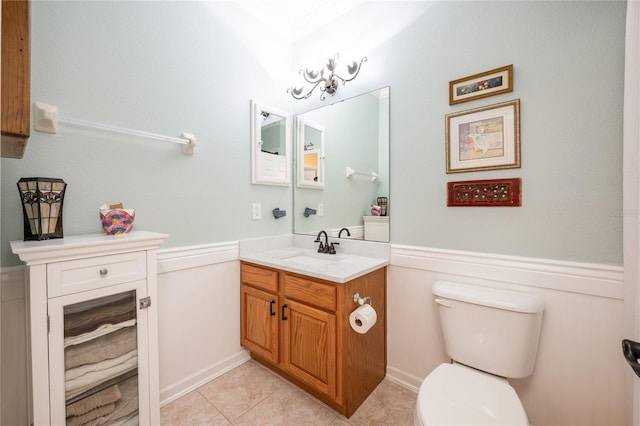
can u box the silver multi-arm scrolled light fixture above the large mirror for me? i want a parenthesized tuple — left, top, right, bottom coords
(287, 52, 367, 101)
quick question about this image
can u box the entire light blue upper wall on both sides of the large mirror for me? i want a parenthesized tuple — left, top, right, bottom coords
(1, 1, 626, 266)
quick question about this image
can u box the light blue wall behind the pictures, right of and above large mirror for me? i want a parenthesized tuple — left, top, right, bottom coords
(294, 1, 624, 265)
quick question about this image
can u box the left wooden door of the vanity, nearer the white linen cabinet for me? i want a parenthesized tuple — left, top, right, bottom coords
(240, 284, 280, 364)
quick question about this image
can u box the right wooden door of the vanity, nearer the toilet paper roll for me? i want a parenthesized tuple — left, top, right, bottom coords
(283, 299, 337, 398)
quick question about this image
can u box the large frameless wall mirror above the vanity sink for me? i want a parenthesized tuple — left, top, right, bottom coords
(293, 87, 391, 241)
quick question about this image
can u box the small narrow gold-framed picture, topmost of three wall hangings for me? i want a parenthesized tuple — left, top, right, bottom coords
(449, 65, 513, 105)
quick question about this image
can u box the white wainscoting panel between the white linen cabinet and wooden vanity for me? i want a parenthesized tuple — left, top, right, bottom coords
(158, 241, 249, 405)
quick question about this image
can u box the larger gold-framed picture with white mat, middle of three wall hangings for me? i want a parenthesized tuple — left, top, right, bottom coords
(445, 99, 520, 173)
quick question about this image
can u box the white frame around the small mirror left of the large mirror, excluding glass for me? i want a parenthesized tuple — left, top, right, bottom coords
(251, 99, 293, 186)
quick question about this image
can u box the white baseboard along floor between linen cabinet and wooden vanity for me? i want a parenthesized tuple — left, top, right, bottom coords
(160, 350, 251, 406)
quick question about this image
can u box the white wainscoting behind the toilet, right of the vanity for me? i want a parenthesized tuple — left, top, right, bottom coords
(387, 245, 632, 425)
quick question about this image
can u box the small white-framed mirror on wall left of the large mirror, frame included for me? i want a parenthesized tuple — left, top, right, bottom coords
(251, 100, 292, 186)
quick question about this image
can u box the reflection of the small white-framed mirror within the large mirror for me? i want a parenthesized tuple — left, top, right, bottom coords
(297, 119, 324, 189)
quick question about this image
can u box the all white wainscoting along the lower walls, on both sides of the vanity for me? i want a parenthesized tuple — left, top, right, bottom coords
(0, 242, 632, 425)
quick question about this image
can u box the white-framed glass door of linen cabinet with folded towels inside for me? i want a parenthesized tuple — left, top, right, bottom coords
(49, 280, 149, 426)
